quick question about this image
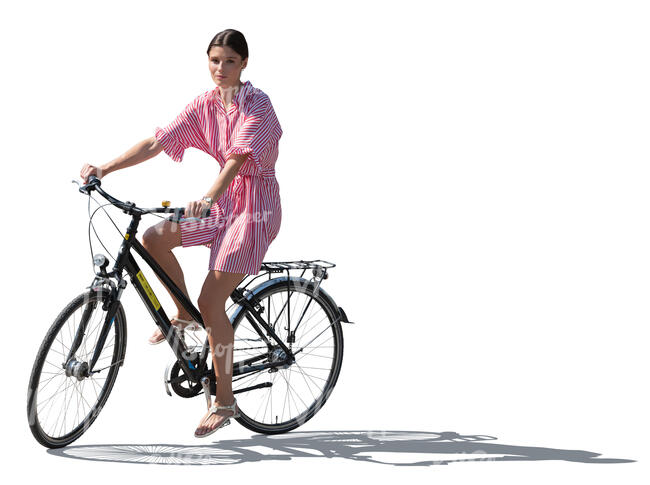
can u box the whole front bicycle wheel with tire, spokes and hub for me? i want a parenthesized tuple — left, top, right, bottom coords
(27, 289, 126, 448)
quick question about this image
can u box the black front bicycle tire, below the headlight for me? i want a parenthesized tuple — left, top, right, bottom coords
(27, 289, 126, 448)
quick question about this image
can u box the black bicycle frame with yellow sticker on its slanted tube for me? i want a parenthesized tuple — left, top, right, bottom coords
(79, 213, 294, 382)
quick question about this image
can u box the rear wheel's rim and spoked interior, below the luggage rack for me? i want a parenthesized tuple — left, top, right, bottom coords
(232, 286, 342, 428)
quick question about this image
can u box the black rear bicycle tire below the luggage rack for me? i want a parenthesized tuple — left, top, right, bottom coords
(233, 278, 343, 435)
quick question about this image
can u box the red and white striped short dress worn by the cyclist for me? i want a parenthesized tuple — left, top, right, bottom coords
(155, 81, 282, 274)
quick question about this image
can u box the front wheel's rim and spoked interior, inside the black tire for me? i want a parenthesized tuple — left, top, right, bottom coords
(31, 295, 119, 441)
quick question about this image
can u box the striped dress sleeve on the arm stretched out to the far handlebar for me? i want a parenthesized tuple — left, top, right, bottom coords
(154, 96, 208, 162)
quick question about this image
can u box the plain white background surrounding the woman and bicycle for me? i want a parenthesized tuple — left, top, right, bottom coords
(0, 0, 650, 483)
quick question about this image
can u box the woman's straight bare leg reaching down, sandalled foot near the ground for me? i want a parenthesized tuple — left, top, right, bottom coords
(196, 270, 246, 434)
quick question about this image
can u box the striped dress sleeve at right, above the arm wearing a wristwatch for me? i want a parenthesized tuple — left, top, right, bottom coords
(225, 96, 282, 160)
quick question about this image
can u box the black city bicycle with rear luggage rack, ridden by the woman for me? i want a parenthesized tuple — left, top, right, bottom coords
(27, 176, 353, 448)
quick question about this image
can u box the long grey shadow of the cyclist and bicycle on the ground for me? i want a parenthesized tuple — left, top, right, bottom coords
(48, 430, 636, 466)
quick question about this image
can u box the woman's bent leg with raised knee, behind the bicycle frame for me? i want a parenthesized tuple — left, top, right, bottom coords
(142, 221, 192, 342)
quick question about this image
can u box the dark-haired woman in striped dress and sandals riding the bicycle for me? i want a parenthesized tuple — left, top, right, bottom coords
(81, 29, 282, 437)
